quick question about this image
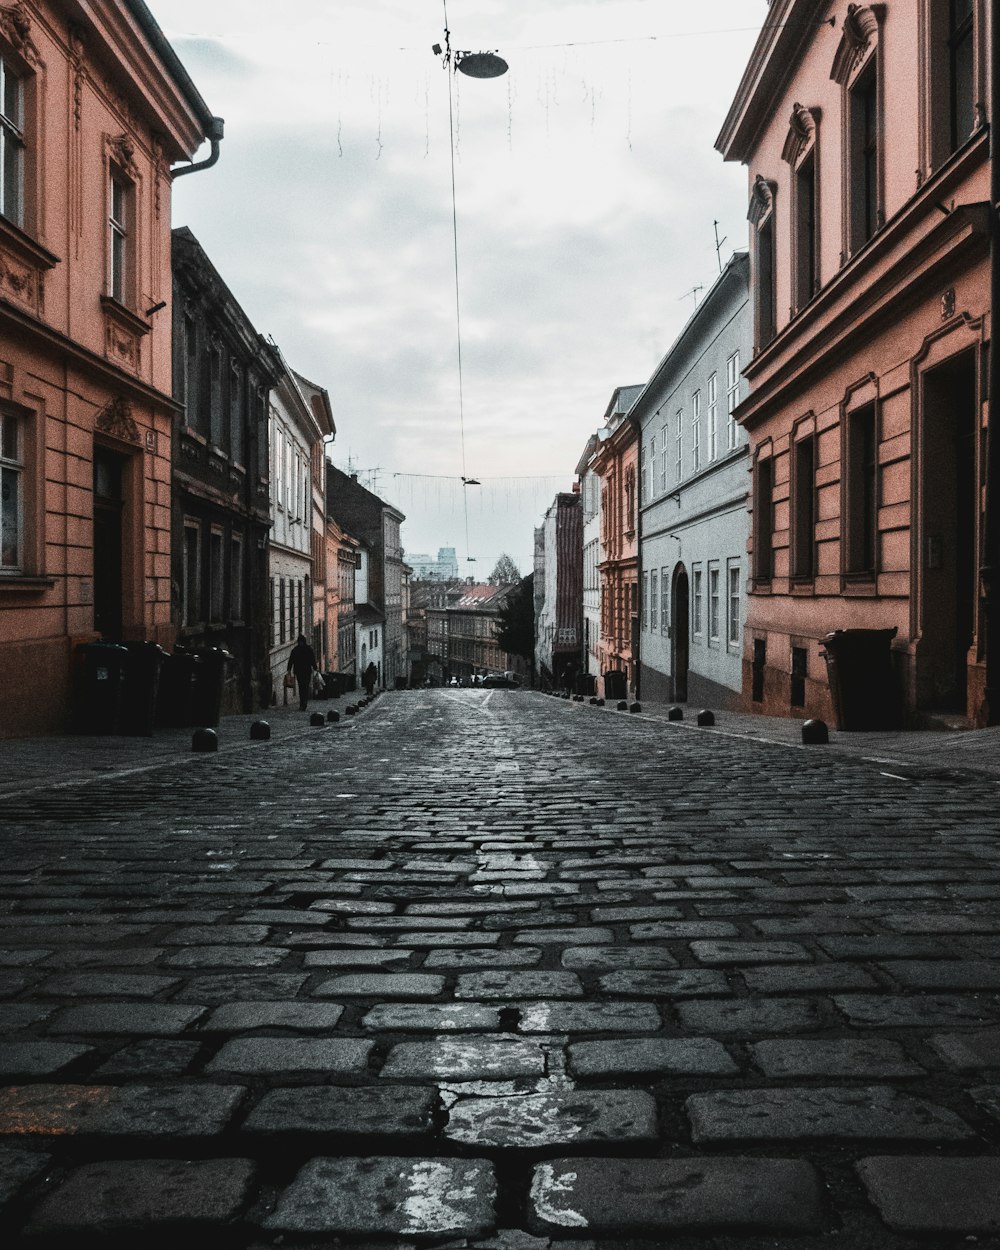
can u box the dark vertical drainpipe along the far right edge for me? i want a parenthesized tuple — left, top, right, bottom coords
(980, 0, 1000, 725)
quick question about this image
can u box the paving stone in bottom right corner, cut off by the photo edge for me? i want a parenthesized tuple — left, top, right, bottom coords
(858, 1155, 1000, 1240)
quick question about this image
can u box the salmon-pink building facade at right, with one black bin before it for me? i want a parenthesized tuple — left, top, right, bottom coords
(716, 0, 990, 724)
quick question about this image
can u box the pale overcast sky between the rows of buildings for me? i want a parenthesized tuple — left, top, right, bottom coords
(149, 0, 768, 579)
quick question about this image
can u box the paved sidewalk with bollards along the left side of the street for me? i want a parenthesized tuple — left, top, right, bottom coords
(0, 690, 364, 796)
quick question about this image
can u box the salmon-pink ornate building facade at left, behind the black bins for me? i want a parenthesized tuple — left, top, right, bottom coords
(0, 0, 221, 736)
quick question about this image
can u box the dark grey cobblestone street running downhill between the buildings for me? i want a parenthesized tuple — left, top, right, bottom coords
(0, 690, 1000, 1250)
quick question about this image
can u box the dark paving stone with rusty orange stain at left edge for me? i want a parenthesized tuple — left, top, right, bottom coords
(0, 1083, 246, 1139)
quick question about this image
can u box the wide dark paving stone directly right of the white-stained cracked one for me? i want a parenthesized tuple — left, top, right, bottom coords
(685, 1085, 975, 1144)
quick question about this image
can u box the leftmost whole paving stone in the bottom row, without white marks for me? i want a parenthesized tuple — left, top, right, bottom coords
(26, 1159, 256, 1238)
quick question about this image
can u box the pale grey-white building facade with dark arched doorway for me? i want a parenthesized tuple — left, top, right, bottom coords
(633, 253, 754, 708)
